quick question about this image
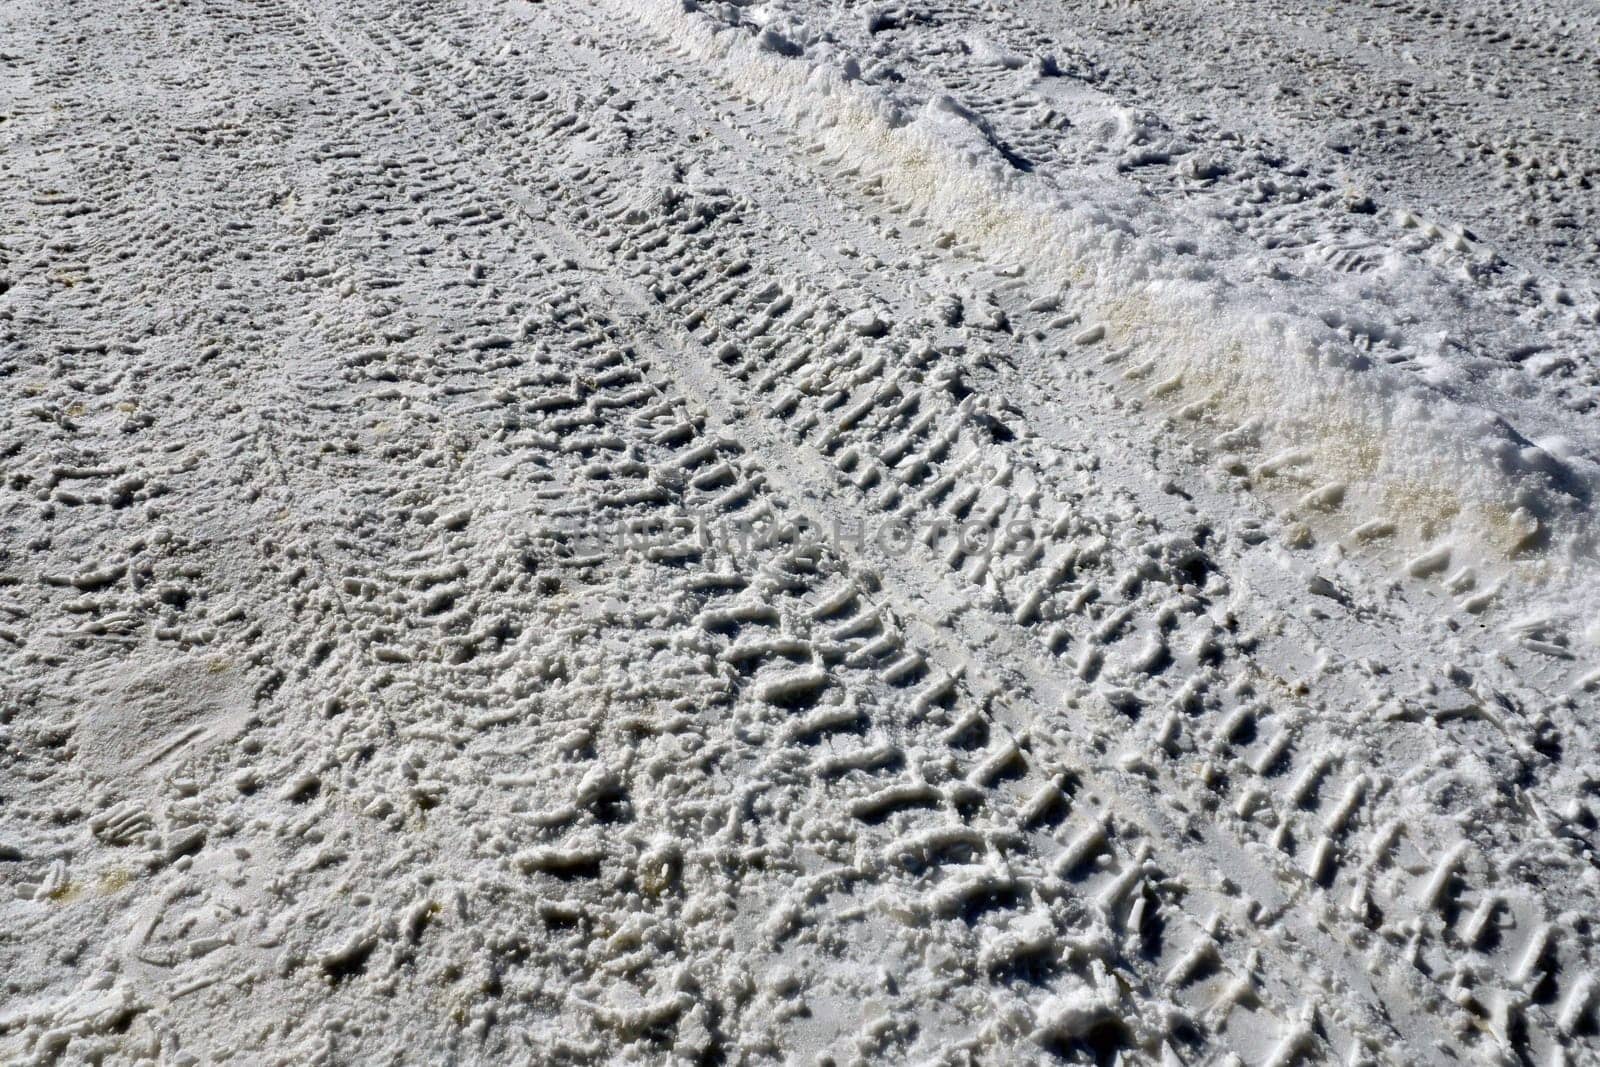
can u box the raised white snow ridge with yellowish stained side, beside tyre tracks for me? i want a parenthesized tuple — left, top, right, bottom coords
(619, 0, 1600, 608)
